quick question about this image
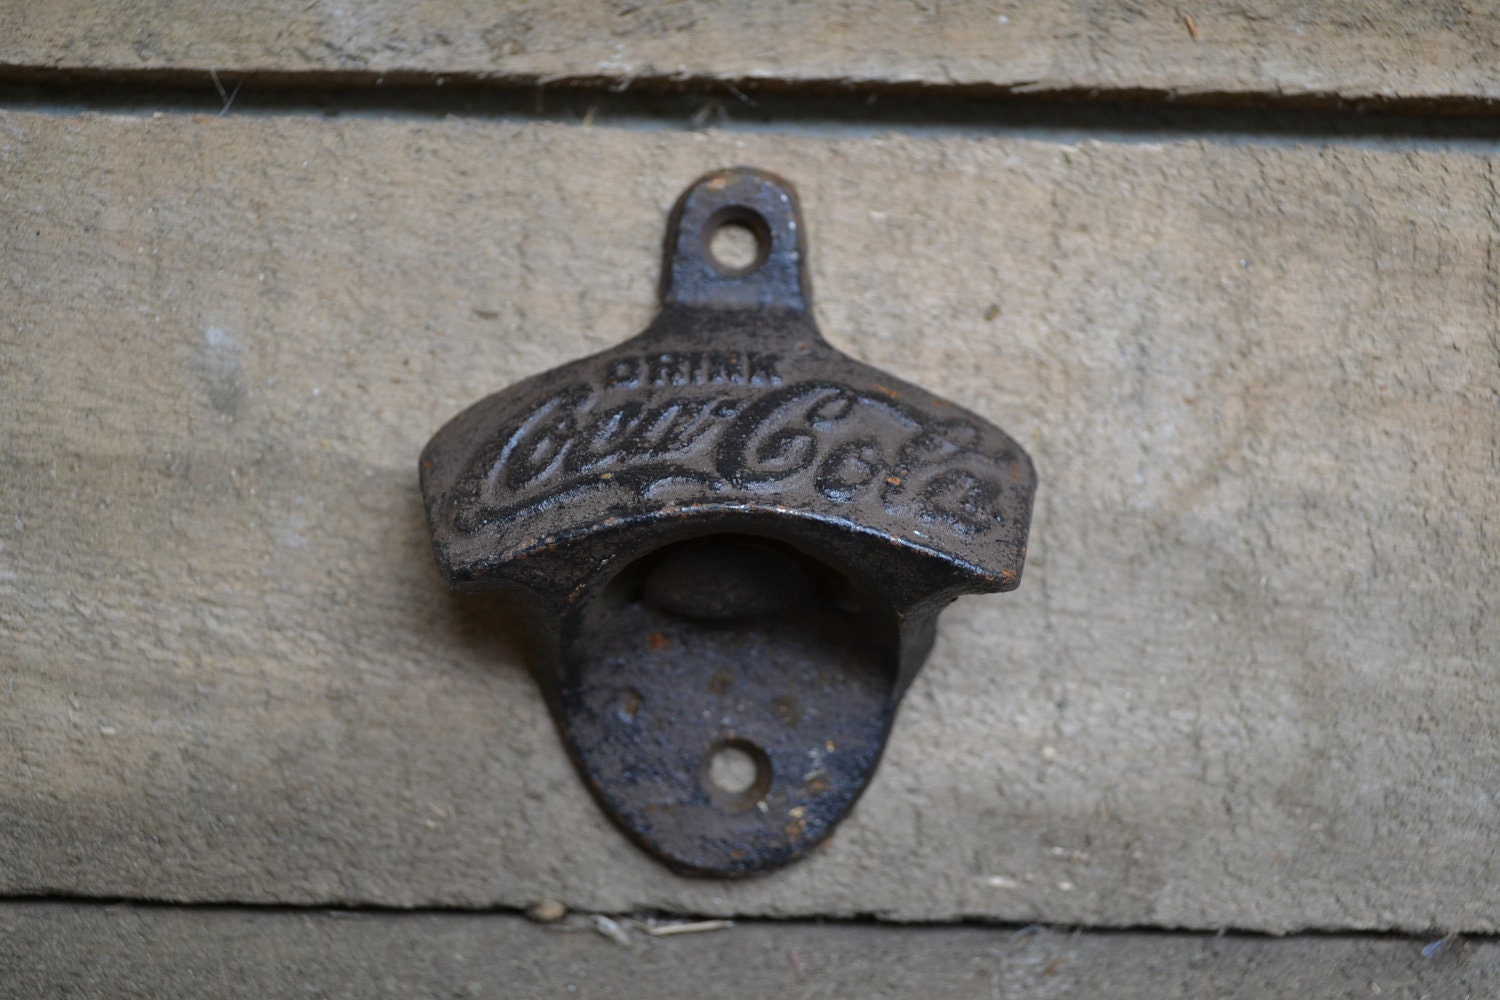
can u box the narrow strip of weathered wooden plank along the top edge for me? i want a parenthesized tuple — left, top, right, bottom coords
(0, 0, 1500, 102)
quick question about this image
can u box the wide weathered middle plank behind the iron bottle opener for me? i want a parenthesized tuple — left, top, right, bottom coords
(0, 112, 1500, 931)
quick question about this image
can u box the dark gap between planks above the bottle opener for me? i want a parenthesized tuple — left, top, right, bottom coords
(0, 66, 1500, 151)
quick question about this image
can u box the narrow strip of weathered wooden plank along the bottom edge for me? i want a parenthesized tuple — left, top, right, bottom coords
(0, 904, 1500, 1000)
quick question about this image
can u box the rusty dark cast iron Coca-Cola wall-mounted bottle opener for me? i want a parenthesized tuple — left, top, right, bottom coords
(422, 169, 1035, 876)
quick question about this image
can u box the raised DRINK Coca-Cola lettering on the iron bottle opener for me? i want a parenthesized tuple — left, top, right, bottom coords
(480, 352, 1016, 537)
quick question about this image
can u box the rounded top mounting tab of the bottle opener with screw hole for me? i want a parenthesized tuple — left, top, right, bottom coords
(662, 166, 813, 312)
